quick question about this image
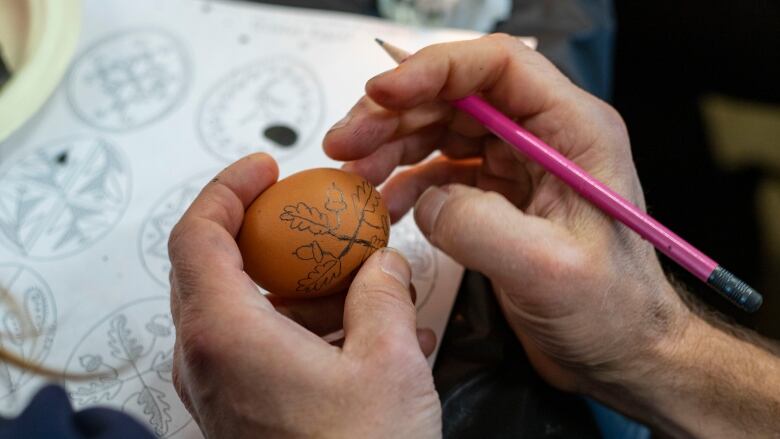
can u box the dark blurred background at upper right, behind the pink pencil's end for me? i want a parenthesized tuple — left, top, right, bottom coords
(611, 0, 780, 339)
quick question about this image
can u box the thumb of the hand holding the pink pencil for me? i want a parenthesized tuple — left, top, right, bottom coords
(414, 184, 562, 286)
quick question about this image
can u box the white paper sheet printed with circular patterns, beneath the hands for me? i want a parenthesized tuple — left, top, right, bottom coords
(0, 0, 532, 438)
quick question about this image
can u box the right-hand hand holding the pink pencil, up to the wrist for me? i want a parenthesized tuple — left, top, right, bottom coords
(324, 35, 689, 392)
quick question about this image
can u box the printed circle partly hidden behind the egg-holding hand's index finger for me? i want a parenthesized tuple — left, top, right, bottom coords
(138, 173, 213, 287)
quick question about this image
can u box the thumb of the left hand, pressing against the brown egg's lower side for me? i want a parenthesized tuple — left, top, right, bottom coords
(344, 248, 422, 355)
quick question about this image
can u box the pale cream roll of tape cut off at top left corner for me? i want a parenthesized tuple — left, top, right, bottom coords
(0, 0, 81, 142)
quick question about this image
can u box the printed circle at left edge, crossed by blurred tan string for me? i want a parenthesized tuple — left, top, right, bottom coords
(0, 264, 57, 399)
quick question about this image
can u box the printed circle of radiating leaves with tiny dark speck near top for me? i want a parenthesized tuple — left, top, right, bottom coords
(0, 138, 131, 259)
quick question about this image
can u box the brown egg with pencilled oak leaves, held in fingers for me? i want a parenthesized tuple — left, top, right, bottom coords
(238, 168, 390, 298)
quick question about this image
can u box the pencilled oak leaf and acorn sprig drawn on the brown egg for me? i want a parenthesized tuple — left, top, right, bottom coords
(279, 181, 390, 293)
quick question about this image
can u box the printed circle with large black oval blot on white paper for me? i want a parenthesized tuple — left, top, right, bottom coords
(198, 58, 324, 162)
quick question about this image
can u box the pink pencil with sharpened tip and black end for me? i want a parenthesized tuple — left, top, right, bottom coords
(376, 39, 763, 312)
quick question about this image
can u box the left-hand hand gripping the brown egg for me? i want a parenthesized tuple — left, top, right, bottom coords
(169, 154, 441, 438)
